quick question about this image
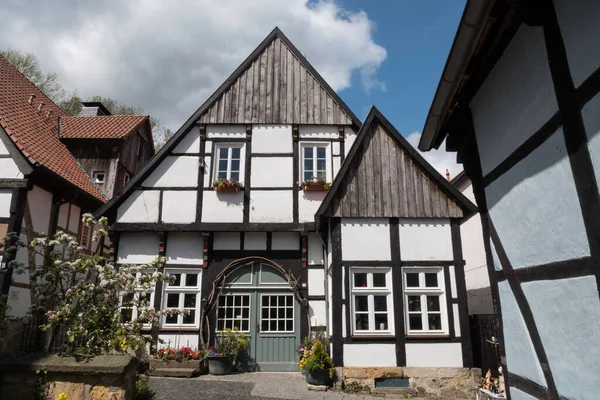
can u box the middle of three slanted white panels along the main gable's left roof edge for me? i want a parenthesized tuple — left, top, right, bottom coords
(142, 156, 199, 187)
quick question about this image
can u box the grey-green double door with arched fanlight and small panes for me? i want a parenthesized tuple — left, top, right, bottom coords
(217, 264, 301, 371)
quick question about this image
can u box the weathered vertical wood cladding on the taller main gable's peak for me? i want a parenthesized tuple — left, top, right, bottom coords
(200, 34, 353, 125)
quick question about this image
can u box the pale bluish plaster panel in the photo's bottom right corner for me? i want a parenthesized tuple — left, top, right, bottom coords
(520, 276, 600, 400)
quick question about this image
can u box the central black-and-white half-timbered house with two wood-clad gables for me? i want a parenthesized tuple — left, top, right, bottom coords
(97, 29, 474, 378)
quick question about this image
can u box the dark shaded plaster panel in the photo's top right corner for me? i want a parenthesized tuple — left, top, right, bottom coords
(554, 0, 600, 87)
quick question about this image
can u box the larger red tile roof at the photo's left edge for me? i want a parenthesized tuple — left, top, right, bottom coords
(0, 56, 107, 202)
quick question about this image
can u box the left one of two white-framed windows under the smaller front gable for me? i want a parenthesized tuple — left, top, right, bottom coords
(350, 267, 394, 336)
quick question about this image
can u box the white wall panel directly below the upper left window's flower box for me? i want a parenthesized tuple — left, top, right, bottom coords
(202, 190, 244, 222)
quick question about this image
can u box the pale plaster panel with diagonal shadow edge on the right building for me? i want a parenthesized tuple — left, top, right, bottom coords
(486, 129, 590, 268)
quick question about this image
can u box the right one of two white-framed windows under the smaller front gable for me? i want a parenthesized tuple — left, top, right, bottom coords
(402, 267, 448, 336)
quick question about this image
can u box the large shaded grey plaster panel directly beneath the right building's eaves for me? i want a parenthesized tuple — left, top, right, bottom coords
(470, 24, 558, 175)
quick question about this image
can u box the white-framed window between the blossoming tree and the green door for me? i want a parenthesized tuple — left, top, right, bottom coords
(163, 268, 202, 327)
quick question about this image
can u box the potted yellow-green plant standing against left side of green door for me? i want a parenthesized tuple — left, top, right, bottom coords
(207, 328, 248, 375)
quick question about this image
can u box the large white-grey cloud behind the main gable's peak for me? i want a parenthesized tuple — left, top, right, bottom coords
(0, 0, 387, 129)
